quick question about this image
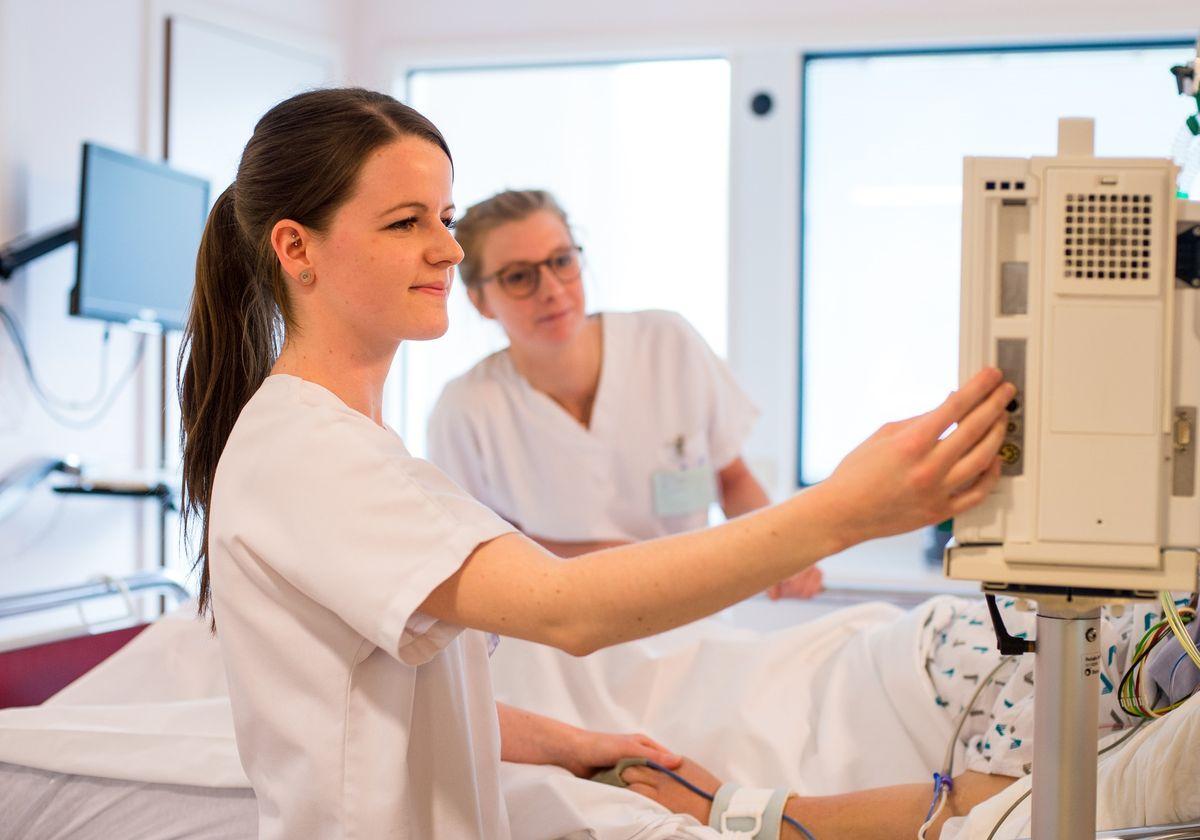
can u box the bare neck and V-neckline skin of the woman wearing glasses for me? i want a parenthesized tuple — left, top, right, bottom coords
(509, 316, 604, 426)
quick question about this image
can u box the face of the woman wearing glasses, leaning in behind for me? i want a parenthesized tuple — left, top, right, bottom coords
(472, 210, 586, 349)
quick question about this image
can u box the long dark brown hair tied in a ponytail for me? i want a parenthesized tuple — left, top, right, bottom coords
(178, 88, 450, 626)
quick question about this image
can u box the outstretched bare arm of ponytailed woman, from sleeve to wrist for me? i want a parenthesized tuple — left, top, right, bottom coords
(421, 487, 846, 655)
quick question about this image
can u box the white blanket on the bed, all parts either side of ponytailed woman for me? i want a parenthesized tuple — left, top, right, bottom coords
(0, 604, 950, 840)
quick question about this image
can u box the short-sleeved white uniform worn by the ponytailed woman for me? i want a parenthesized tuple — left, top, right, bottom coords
(209, 376, 511, 840)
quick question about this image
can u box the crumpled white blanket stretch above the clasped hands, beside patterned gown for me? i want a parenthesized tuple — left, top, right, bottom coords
(492, 602, 952, 794)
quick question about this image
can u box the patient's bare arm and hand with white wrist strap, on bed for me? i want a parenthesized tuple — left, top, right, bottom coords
(622, 760, 1016, 840)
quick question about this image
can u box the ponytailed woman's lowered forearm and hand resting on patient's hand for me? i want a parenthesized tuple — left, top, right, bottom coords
(496, 703, 682, 776)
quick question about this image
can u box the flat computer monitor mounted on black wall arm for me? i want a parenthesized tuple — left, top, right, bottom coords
(71, 143, 209, 329)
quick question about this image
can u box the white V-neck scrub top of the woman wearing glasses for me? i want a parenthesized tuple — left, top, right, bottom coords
(428, 311, 757, 541)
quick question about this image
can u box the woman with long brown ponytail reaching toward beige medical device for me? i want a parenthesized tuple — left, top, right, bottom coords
(181, 83, 1012, 840)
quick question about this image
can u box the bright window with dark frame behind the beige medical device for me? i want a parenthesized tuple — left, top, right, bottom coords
(798, 42, 1195, 484)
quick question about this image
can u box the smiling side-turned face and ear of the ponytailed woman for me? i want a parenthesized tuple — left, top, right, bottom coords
(301, 137, 462, 353)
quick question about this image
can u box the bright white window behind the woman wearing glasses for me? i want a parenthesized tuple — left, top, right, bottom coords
(388, 59, 730, 455)
